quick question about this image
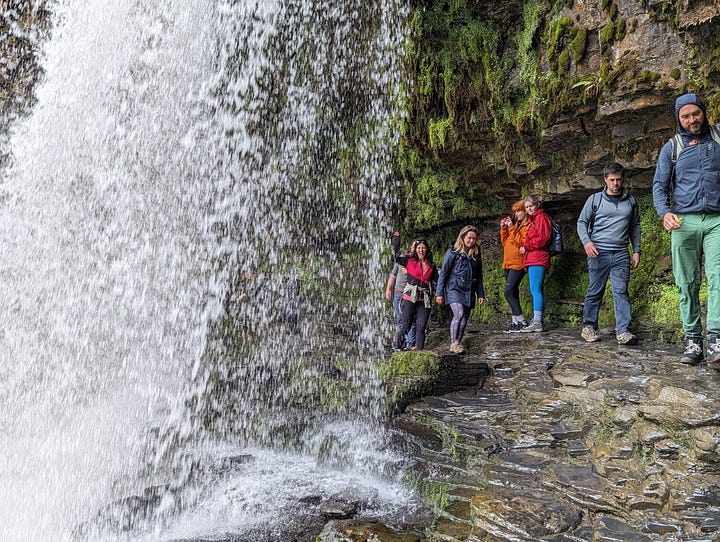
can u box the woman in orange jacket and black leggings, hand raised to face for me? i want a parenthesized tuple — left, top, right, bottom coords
(500, 199, 530, 333)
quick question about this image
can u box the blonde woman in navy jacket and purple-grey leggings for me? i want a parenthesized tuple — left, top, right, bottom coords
(435, 226, 485, 354)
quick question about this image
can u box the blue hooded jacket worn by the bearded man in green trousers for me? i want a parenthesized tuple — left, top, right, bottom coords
(653, 93, 720, 219)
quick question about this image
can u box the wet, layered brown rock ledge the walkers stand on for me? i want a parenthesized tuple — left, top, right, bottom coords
(320, 329, 720, 542)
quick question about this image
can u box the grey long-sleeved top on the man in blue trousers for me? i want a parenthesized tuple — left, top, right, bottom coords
(577, 190, 640, 254)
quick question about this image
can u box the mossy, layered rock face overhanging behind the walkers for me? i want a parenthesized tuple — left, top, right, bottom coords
(398, 0, 720, 340)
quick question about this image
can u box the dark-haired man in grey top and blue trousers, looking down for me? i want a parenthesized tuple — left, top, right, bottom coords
(577, 163, 640, 344)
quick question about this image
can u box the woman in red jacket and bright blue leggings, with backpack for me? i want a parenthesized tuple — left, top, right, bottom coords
(520, 196, 552, 333)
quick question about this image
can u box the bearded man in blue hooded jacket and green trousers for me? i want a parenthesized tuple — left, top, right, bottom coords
(653, 93, 720, 364)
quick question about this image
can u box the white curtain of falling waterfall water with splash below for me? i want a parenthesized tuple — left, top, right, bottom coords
(0, 0, 422, 542)
